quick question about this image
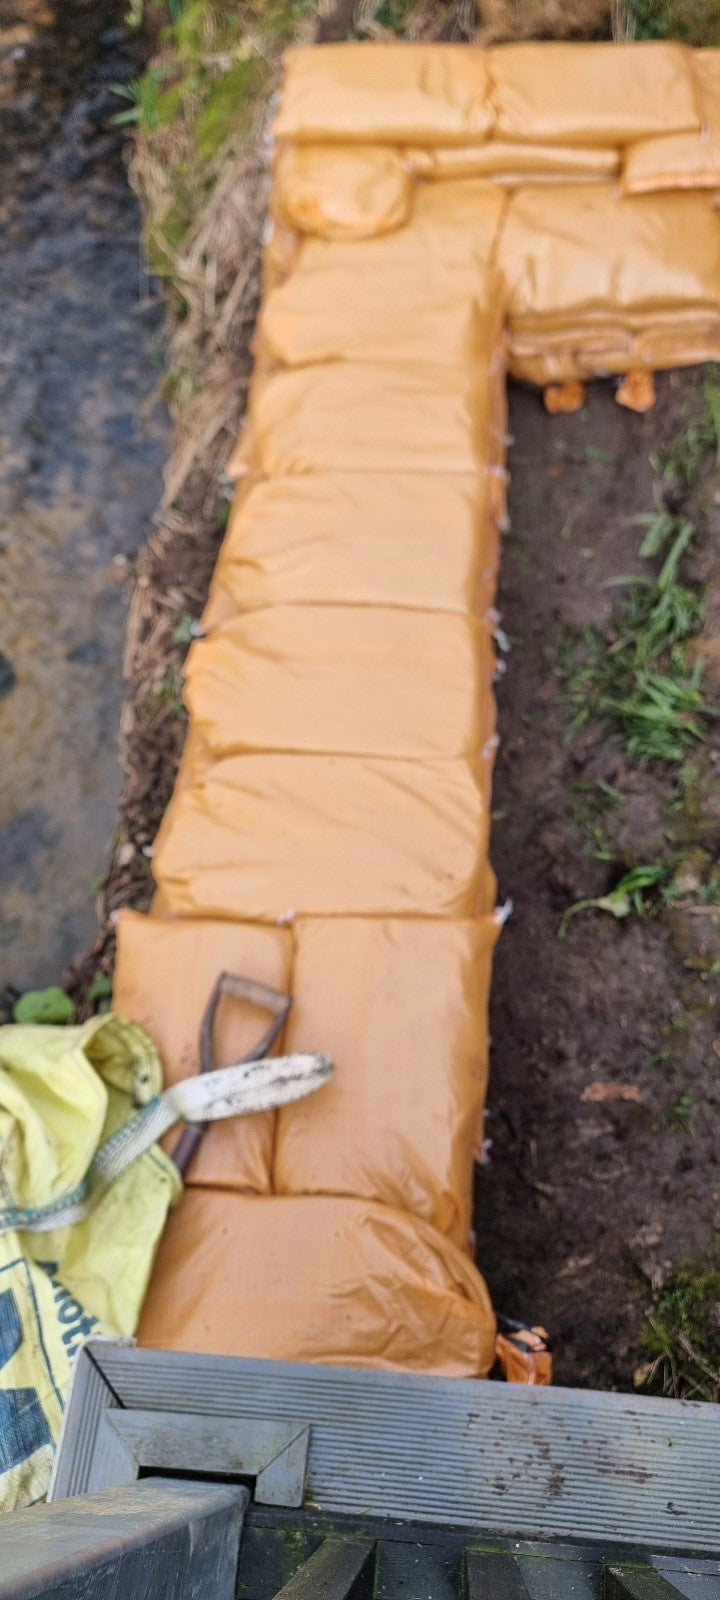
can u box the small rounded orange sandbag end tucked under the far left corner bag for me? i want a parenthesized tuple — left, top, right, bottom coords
(272, 144, 413, 238)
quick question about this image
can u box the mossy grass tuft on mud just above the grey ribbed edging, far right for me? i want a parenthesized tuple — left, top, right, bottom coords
(635, 1258, 720, 1402)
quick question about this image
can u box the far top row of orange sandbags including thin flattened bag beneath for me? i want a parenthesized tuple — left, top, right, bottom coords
(275, 42, 720, 194)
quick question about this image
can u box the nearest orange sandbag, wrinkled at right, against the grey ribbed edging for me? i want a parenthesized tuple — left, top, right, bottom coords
(138, 1189, 496, 1378)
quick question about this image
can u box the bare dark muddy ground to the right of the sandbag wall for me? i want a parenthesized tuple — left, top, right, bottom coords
(477, 373, 720, 1389)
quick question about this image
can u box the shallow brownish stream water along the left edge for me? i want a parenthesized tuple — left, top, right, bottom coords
(0, 0, 168, 990)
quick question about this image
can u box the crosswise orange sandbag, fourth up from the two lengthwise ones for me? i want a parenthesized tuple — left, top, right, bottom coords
(227, 362, 491, 477)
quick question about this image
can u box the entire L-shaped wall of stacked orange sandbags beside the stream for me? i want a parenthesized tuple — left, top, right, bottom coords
(114, 43, 720, 1376)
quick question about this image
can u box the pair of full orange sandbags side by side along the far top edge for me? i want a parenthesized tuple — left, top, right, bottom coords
(275, 42, 701, 146)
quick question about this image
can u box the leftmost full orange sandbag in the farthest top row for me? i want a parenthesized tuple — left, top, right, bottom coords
(275, 43, 493, 144)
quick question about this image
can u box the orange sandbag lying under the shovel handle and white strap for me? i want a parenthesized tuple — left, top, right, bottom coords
(112, 910, 293, 1194)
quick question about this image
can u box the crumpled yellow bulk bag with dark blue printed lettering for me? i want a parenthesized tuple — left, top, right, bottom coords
(0, 1016, 181, 1510)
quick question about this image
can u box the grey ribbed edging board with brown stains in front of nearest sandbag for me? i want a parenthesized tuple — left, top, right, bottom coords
(54, 1341, 720, 1554)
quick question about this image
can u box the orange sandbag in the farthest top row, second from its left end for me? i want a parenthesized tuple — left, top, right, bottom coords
(488, 42, 699, 147)
